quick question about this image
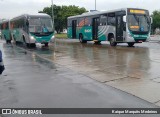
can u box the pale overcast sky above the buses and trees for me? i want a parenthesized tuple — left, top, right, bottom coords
(0, 0, 160, 19)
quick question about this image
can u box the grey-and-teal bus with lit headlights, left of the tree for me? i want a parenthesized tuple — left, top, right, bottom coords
(11, 13, 54, 47)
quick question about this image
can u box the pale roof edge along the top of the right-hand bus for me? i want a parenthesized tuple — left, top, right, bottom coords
(68, 8, 149, 19)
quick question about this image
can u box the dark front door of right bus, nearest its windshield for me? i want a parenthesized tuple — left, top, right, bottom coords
(116, 15, 123, 42)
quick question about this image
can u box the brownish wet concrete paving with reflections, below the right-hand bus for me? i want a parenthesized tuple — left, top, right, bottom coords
(17, 40, 160, 106)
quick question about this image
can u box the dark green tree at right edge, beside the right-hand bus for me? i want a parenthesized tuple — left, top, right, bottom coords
(151, 10, 160, 30)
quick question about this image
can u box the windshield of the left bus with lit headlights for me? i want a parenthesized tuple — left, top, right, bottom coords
(29, 18, 53, 33)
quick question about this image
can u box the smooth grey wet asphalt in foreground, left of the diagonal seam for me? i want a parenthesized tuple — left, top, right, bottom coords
(0, 40, 158, 117)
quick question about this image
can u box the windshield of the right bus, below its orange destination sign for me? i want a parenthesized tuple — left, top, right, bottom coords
(128, 14, 150, 32)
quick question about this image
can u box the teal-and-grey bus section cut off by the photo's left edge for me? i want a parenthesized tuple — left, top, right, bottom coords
(0, 20, 11, 43)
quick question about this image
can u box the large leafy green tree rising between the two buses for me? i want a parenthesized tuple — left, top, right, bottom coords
(39, 5, 87, 33)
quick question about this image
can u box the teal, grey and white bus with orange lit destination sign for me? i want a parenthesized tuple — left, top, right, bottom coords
(67, 8, 152, 46)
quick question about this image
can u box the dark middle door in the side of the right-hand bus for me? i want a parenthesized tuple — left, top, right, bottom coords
(92, 18, 99, 40)
